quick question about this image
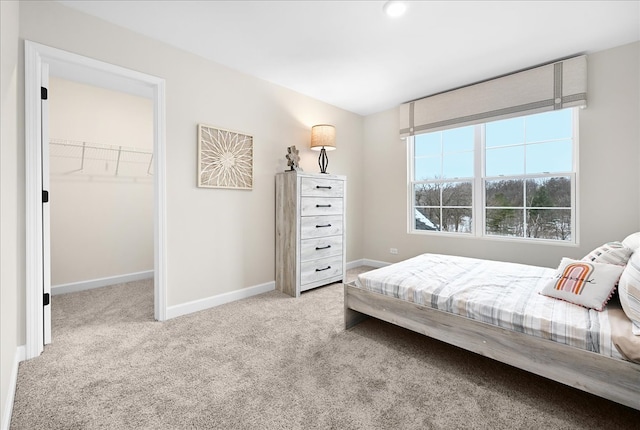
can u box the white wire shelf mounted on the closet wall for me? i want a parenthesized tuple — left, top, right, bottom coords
(49, 139, 153, 176)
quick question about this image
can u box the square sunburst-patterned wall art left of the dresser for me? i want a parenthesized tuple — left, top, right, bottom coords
(198, 124, 253, 190)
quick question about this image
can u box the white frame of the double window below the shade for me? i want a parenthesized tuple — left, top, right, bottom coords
(406, 108, 580, 247)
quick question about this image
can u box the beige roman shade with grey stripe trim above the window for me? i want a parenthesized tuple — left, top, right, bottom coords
(400, 55, 587, 137)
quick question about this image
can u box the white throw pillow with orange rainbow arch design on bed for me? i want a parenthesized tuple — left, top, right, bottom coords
(540, 257, 624, 311)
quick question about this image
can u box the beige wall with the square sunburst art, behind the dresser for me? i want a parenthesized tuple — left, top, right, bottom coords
(13, 2, 363, 332)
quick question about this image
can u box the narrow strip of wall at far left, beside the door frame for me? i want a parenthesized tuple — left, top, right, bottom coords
(0, 1, 24, 429)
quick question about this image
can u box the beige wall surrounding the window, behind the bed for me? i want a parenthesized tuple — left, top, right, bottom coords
(362, 43, 640, 267)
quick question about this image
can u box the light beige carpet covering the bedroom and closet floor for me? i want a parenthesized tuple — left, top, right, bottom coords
(11, 271, 640, 430)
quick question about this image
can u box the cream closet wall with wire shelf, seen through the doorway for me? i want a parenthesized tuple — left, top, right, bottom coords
(49, 77, 153, 287)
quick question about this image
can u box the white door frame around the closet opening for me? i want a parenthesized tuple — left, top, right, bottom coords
(24, 40, 167, 359)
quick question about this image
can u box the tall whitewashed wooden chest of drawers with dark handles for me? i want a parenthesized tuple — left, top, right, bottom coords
(276, 171, 346, 297)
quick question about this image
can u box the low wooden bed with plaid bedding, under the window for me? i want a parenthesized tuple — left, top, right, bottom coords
(344, 233, 640, 410)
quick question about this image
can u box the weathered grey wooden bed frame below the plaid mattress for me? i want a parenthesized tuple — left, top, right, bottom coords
(344, 282, 640, 410)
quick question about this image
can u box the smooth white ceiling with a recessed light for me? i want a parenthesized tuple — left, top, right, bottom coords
(60, 0, 640, 115)
